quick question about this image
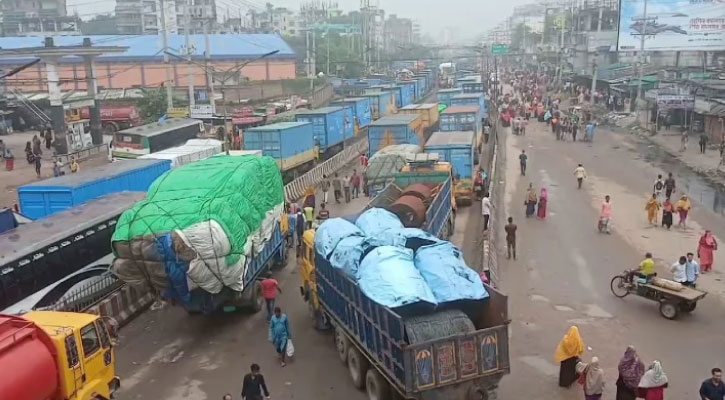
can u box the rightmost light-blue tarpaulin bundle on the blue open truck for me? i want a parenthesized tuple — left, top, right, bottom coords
(415, 242, 488, 303)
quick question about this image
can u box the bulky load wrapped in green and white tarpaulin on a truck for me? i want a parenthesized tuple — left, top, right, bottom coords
(112, 156, 284, 303)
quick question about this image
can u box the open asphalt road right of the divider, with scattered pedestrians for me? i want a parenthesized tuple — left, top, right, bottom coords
(498, 114, 725, 399)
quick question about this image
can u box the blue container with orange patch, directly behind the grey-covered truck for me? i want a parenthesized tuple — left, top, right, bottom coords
(368, 114, 426, 157)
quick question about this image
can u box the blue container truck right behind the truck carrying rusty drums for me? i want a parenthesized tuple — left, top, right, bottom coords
(423, 131, 476, 205)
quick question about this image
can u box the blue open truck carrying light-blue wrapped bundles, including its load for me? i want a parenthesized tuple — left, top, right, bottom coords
(299, 165, 510, 400)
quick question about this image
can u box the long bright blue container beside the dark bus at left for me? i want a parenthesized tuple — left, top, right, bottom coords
(18, 160, 171, 219)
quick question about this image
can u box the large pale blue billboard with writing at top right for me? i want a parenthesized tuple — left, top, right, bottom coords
(617, 0, 725, 51)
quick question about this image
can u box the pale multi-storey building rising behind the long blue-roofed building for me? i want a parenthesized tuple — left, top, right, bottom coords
(116, 0, 217, 35)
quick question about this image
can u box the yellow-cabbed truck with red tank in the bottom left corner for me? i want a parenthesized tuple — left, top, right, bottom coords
(0, 311, 120, 400)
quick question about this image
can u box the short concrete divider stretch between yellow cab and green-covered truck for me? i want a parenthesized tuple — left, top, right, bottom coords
(86, 285, 154, 327)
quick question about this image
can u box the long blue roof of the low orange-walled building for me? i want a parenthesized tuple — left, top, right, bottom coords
(0, 34, 296, 64)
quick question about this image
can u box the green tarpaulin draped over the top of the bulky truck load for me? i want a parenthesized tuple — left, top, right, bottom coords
(112, 156, 284, 264)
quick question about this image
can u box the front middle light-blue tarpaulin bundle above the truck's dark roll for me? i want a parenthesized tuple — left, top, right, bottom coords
(358, 246, 437, 307)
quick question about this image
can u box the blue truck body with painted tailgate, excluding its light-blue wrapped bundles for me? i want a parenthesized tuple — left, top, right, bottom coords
(299, 162, 510, 400)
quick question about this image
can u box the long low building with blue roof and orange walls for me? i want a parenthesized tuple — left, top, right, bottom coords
(0, 34, 296, 93)
